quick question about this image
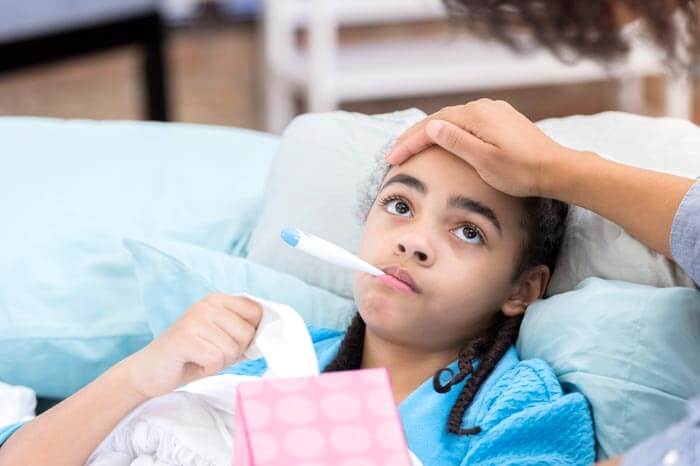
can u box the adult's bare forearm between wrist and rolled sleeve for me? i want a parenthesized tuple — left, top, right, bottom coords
(544, 149, 694, 258)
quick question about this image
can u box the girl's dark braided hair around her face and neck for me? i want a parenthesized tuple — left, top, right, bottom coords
(325, 157, 569, 435)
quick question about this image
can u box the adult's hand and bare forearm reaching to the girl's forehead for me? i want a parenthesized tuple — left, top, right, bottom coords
(387, 99, 693, 258)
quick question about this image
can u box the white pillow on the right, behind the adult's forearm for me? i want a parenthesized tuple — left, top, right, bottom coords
(538, 112, 700, 295)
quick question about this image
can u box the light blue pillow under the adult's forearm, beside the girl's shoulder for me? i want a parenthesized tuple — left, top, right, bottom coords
(518, 278, 700, 458)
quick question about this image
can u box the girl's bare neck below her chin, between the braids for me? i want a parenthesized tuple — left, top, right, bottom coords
(362, 329, 459, 404)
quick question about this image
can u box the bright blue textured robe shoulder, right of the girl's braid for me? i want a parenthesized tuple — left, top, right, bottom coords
(465, 349, 595, 465)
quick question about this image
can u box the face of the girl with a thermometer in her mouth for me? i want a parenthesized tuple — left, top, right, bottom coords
(353, 147, 544, 350)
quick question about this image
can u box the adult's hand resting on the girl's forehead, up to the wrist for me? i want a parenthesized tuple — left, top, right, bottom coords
(387, 99, 572, 197)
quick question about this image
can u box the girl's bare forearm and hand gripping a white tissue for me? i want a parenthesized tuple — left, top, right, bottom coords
(0, 294, 262, 466)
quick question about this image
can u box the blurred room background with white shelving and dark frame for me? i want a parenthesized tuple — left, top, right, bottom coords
(0, 0, 700, 132)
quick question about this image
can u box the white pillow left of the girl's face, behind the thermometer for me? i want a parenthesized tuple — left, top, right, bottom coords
(248, 109, 426, 298)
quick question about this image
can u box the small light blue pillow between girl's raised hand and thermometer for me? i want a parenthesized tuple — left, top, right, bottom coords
(124, 239, 355, 336)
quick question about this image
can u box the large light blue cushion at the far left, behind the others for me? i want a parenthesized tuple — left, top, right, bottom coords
(0, 118, 279, 398)
